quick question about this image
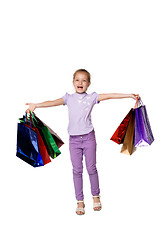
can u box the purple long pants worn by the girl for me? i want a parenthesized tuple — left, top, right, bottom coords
(69, 130, 100, 201)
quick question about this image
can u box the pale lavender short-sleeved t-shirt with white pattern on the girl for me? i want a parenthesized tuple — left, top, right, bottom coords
(62, 92, 99, 135)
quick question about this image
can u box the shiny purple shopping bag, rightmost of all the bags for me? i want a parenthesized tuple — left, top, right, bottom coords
(134, 100, 154, 147)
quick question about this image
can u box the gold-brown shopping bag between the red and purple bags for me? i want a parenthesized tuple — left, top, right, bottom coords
(121, 109, 135, 155)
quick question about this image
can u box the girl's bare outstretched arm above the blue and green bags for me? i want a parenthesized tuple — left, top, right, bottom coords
(26, 98, 64, 113)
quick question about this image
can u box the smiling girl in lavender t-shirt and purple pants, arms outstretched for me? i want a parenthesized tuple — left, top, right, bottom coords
(26, 69, 139, 215)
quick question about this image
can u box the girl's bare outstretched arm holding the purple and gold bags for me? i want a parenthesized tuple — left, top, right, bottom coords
(98, 93, 139, 101)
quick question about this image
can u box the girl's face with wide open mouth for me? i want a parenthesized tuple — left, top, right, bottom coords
(73, 72, 91, 93)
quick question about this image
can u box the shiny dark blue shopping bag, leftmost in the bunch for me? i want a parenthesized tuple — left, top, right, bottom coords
(16, 118, 43, 167)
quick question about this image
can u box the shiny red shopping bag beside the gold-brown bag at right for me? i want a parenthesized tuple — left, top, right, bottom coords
(110, 109, 132, 144)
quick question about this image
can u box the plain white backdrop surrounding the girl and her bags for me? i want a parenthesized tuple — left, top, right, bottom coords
(0, 0, 160, 240)
